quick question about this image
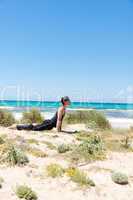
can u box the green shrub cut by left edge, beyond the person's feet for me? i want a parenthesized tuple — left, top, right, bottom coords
(0, 109, 15, 127)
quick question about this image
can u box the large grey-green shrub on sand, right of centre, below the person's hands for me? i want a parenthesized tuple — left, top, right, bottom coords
(71, 135, 106, 161)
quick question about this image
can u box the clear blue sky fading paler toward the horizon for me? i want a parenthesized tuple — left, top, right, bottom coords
(0, 0, 133, 100)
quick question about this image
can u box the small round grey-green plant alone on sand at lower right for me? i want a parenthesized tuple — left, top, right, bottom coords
(112, 172, 128, 185)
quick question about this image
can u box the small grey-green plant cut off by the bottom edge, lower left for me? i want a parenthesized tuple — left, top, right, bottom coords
(16, 185, 38, 200)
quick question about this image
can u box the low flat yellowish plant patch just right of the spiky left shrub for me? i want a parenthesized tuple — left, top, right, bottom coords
(27, 147, 47, 158)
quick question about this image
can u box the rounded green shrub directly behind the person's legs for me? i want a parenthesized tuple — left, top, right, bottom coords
(21, 108, 44, 124)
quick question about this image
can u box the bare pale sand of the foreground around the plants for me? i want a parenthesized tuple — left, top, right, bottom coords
(0, 122, 133, 200)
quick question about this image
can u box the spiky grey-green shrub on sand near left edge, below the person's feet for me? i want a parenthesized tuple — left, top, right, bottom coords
(4, 145, 29, 166)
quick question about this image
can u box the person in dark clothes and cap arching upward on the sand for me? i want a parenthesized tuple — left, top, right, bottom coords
(17, 96, 74, 133)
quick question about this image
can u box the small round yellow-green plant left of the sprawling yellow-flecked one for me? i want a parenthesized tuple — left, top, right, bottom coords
(46, 164, 64, 178)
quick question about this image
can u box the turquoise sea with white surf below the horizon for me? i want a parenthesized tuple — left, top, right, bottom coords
(0, 100, 133, 119)
